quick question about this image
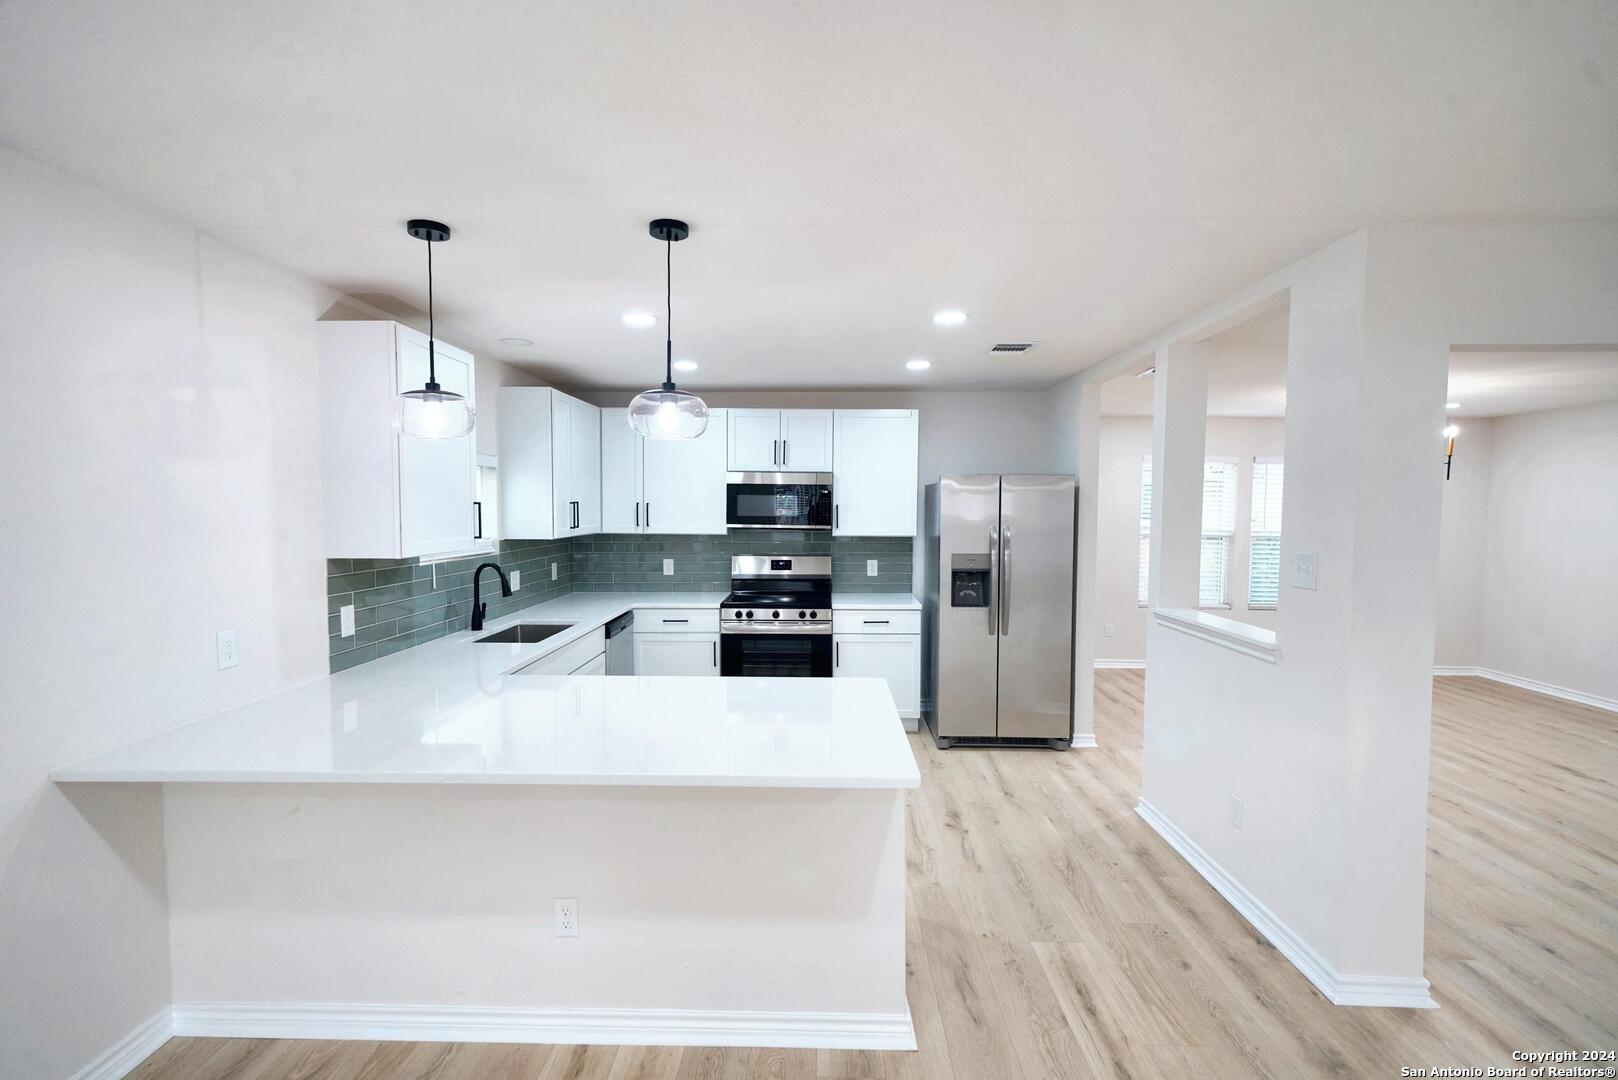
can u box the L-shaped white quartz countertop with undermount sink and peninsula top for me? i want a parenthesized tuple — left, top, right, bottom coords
(52, 593, 921, 789)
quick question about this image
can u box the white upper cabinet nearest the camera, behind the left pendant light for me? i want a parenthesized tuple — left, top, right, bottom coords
(316, 321, 477, 559)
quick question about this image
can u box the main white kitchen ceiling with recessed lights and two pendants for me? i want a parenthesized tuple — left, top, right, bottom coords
(0, 0, 1618, 389)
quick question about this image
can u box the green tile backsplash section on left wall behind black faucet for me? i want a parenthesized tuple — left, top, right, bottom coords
(325, 541, 573, 672)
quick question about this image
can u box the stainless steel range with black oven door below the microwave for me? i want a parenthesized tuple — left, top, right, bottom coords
(718, 555, 832, 678)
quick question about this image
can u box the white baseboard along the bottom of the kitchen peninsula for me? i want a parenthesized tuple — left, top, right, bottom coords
(173, 1002, 916, 1049)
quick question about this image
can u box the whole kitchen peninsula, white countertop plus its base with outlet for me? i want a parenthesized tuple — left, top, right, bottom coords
(53, 594, 919, 1049)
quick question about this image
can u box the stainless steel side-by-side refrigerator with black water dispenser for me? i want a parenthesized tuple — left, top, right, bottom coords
(922, 476, 1076, 748)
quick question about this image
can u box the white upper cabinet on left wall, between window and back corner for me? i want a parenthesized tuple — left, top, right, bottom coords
(498, 387, 602, 539)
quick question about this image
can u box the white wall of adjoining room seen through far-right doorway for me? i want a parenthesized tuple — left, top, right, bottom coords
(1435, 402, 1618, 701)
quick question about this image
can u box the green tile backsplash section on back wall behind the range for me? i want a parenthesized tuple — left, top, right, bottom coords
(573, 529, 913, 593)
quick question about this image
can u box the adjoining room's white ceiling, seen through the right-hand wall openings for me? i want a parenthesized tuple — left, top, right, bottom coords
(1102, 306, 1618, 418)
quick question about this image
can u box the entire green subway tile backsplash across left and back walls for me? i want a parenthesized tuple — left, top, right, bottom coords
(325, 529, 913, 672)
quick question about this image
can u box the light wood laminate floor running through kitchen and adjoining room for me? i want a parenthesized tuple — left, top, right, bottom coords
(133, 670, 1618, 1080)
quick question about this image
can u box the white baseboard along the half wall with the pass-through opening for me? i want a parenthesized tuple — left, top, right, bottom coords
(1134, 798, 1438, 1009)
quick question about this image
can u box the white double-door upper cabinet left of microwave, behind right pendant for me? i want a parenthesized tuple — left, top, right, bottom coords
(601, 408, 733, 536)
